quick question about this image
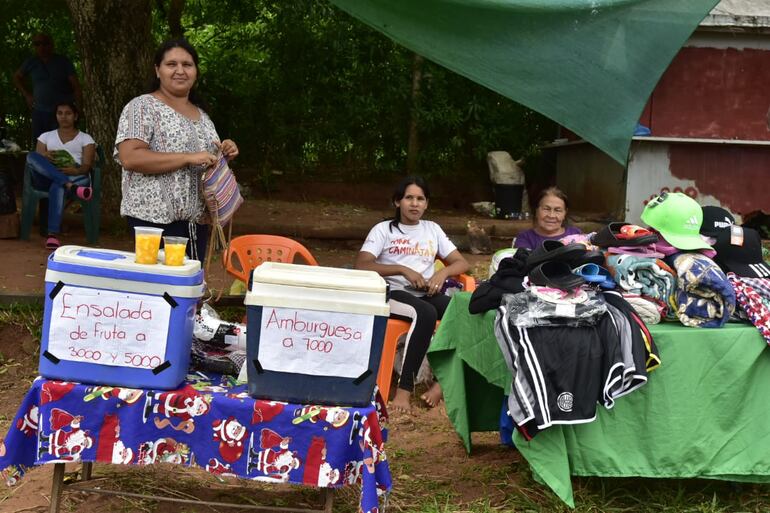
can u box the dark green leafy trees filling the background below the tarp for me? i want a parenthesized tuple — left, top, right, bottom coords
(0, 0, 554, 184)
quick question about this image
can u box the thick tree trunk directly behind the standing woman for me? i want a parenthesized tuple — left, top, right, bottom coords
(67, 0, 153, 219)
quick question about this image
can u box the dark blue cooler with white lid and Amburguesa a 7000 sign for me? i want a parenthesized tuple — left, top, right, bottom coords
(245, 262, 390, 406)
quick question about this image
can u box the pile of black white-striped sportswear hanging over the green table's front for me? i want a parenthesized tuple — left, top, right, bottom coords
(488, 240, 660, 439)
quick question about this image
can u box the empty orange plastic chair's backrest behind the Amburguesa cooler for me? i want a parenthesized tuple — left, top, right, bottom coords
(223, 235, 318, 283)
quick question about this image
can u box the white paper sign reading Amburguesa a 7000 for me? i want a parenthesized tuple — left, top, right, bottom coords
(257, 306, 374, 378)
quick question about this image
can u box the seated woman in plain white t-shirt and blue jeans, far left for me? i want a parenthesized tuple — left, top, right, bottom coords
(27, 102, 96, 249)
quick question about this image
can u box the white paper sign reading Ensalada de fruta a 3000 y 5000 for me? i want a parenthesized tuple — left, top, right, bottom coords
(48, 285, 171, 369)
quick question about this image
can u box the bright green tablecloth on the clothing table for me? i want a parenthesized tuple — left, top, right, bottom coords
(428, 293, 770, 507)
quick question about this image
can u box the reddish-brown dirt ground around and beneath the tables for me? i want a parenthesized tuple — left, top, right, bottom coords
(0, 200, 526, 513)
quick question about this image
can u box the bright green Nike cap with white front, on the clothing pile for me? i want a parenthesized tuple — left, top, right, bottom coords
(642, 192, 711, 249)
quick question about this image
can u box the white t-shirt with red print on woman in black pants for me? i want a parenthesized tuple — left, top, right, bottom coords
(361, 220, 457, 296)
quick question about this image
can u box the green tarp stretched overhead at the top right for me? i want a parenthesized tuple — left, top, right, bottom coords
(331, 0, 717, 165)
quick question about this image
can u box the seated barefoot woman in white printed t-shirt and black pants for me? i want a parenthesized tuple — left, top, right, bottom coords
(356, 177, 468, 413)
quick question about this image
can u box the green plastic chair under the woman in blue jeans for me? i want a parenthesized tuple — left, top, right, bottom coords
(19, 146, 104, 244)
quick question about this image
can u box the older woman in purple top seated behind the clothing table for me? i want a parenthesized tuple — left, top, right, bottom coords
(513, 187, 582, 249)
